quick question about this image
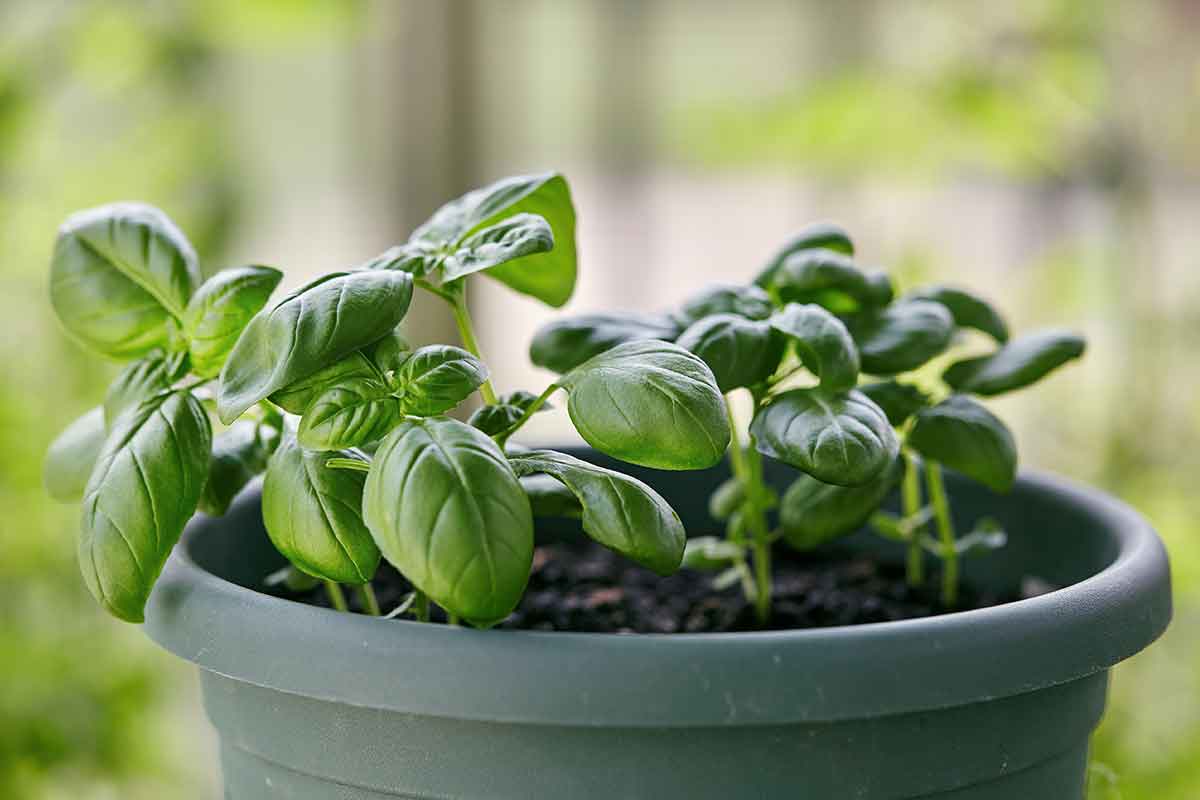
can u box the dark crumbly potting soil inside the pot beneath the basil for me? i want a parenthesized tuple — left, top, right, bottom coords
(265, 543, 1021, 633)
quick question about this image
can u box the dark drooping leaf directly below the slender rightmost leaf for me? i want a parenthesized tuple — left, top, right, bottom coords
(908, 395, 1016, 492)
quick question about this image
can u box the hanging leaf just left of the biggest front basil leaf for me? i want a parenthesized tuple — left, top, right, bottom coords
(263, 437, 379, 584)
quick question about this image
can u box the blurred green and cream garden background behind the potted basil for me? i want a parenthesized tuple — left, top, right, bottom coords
(0, 0, 1200, 800)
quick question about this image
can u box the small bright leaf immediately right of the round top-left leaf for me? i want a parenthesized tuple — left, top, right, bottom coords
(184, 266, 283, 378)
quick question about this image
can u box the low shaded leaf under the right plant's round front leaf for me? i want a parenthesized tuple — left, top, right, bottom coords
(779, 459, 901, 551)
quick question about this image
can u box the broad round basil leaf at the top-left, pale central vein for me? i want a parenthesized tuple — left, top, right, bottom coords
(50, 203, 199, 359)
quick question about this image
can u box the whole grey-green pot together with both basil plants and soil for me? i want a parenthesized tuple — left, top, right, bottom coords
(46, 174, 1170, 800)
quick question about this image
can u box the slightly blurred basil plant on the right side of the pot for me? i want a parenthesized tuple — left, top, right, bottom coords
(530, 224, 1085, 621)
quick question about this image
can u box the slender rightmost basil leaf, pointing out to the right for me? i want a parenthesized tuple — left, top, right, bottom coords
(942, 331, 1087, 396)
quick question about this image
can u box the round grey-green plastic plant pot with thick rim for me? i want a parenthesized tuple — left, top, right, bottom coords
(146, 451, 1171, 800)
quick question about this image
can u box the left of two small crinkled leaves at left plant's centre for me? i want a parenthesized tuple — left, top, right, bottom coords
(296, 378, 403, 450)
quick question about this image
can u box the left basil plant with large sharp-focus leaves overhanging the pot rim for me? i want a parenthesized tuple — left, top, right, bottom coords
(46, 174, 730, 626)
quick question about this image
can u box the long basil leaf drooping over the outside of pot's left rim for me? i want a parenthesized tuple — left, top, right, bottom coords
(78, 391, 212, 622)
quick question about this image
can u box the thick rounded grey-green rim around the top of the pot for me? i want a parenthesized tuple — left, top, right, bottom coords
(146, 473, 1171, 727)
